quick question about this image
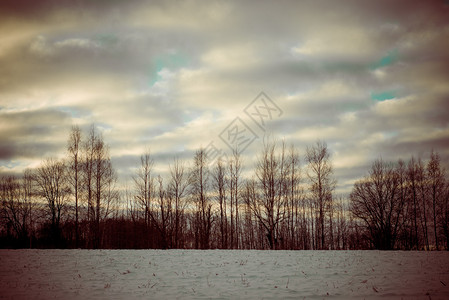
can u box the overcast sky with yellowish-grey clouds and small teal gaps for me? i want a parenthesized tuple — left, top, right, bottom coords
(0, 0, 449, 193)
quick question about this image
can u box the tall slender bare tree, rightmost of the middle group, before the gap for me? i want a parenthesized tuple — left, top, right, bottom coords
(306, 141, 336, 249)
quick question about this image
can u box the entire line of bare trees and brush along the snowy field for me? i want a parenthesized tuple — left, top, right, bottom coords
(0, 126, 449, 250)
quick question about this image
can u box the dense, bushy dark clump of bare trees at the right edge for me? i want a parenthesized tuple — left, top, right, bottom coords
(350, 151, 449, 250)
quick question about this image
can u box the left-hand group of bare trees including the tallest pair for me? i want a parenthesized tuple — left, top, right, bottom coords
(0, 126, 119, 248)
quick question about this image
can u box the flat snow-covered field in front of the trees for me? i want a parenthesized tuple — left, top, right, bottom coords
(0, 250, 449, 299)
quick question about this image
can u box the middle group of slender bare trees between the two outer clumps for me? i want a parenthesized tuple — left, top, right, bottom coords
(125, 142, 349, 249)
